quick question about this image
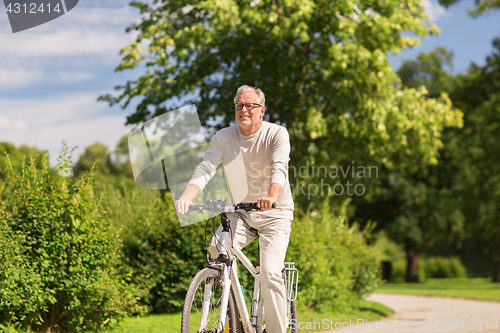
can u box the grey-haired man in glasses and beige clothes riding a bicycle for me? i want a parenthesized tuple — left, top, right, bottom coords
(175, 85, 294, 333)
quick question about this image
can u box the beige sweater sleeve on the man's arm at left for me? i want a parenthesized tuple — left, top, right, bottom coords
(188, 132, 222, 191)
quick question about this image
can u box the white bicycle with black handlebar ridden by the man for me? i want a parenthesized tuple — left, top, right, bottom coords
(181, 200, 298, 333)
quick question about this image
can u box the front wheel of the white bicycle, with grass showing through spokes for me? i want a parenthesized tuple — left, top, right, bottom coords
(181, 268, 238, 333)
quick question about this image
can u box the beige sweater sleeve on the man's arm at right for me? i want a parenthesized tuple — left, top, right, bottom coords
(270, 127, 290, 188)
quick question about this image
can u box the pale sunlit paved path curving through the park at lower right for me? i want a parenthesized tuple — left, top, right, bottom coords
(318, 294, 500, 333)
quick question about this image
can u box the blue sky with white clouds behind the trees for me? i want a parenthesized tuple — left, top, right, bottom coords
(0, 0, 500, 165)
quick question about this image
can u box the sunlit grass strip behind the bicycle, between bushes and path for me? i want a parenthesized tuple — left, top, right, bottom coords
(108, 301, 393, 333)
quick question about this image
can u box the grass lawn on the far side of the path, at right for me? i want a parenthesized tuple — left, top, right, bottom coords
(377, 278, 500, 302)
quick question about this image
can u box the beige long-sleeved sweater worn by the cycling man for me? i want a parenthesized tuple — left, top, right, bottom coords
(189, 121, 294, 216)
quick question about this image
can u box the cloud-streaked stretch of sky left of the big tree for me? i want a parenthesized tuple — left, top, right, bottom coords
(0, 0, 140, 165)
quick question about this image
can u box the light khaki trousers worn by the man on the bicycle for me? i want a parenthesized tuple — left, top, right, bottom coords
(208, 209, 293, 333)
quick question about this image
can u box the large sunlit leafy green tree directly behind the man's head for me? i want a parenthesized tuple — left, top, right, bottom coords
(100, 0, 461, 205)
